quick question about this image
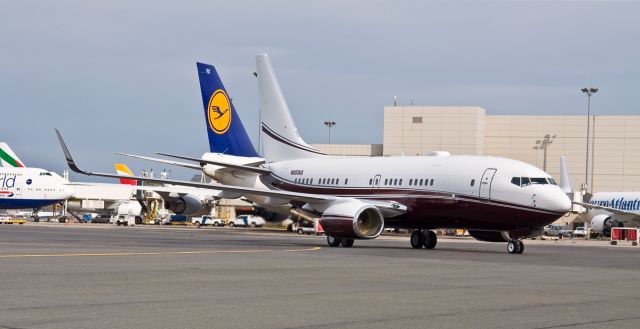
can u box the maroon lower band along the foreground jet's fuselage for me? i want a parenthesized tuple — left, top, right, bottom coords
(262, 175, 563, 230)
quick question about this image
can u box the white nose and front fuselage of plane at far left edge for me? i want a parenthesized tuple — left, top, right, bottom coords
(0, 167, 73, 209)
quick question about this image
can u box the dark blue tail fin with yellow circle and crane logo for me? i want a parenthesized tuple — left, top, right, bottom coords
(196, 63, 259, 157)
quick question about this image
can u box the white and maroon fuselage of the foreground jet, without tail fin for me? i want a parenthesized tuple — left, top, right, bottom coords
(265, 156, 571, 227)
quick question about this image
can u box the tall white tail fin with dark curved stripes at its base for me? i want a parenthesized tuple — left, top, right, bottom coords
(256, 54, 323, 162)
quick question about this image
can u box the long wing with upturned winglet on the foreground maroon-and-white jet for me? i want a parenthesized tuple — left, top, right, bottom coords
(56, 129, 338, 203)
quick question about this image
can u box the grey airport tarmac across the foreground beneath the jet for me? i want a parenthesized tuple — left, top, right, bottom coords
(0, 223, 640, 328)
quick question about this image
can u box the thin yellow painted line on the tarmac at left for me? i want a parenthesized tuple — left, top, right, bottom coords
(0, 247, 322, 259)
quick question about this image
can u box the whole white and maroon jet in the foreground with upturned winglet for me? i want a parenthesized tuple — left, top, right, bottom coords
(58, 54, 571, 253)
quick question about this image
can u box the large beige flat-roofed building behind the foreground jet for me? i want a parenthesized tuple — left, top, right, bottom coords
(314, 106, 640, 193)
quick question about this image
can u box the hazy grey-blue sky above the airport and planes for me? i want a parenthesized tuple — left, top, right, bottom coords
(0, 0, 640, 178)
